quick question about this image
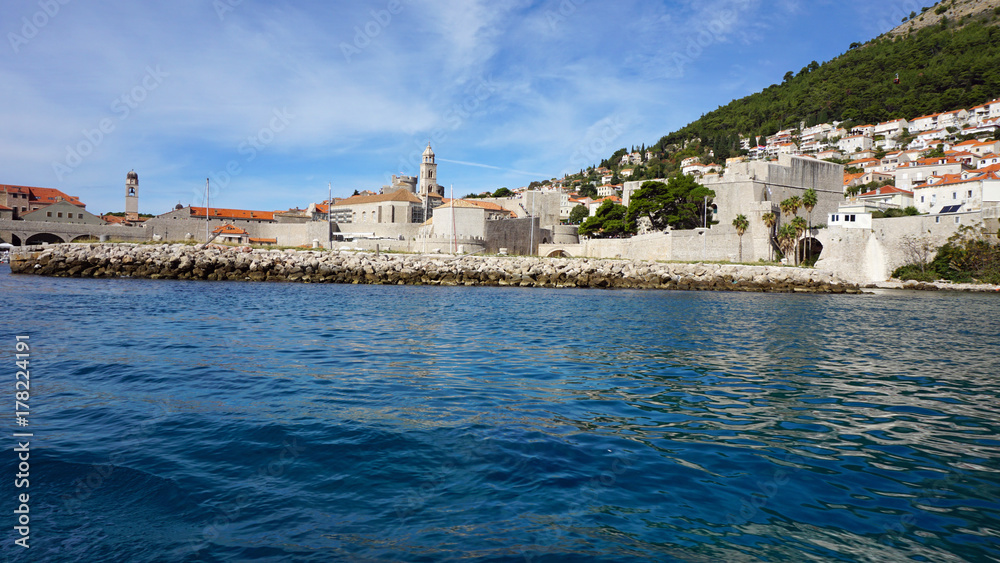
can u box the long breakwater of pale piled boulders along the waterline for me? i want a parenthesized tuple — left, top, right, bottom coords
(11, 244, 860, 293)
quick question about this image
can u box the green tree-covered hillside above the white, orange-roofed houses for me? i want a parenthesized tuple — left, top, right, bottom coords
(652, 9, 1000, 159)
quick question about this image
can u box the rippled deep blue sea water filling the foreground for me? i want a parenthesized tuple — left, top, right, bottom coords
(0, 267, 1000, 562)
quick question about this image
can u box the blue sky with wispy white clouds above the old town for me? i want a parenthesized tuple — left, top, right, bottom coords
(0, 0, 931, 214)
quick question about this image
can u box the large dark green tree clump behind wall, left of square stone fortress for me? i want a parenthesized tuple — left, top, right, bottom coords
(628, 175, 715, 231)
